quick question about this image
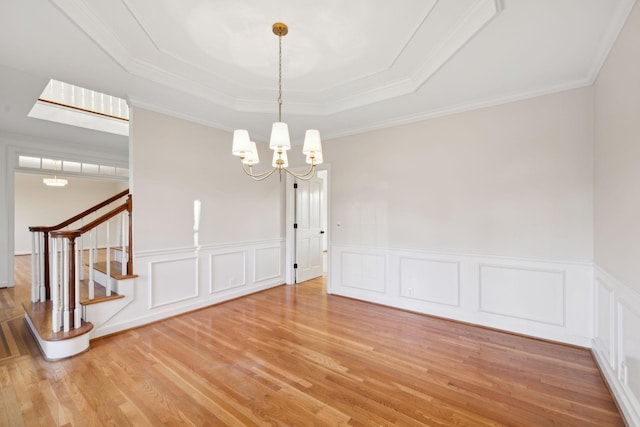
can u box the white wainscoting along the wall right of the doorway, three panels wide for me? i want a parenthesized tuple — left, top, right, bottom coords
(330, 245, 594, 347)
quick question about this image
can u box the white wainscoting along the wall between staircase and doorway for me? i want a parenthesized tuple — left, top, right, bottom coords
(91, 239, 284, 339)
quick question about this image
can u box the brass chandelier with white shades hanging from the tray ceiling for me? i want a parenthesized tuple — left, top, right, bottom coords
(231, 22, 322, 181)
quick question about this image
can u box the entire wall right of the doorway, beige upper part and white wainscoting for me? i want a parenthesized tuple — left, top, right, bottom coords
(324, 88, 593, 346)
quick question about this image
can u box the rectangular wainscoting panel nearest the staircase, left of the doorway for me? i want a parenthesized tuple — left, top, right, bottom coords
(149, 256, 198, 308)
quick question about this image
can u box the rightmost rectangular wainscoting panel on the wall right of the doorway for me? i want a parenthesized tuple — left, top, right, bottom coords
(480, 265, 566, 326)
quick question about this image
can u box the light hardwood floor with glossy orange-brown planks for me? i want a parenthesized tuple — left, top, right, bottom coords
(0, 257, 623, 426)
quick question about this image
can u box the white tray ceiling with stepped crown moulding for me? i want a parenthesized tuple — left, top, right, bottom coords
(0, 0, 635, 152)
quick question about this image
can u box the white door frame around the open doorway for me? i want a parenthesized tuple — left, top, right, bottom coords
(284, 163, 332, 294)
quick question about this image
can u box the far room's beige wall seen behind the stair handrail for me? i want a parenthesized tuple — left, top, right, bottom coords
(14, 173, 128, 255)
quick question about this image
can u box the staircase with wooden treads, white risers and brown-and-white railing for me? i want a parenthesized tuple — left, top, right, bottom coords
(23, 190, 136, 360)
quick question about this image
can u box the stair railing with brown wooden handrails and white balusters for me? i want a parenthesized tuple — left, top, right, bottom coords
(29, 190, 133, 332)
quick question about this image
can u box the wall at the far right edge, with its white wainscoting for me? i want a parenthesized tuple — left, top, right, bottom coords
(593, 3, 640, 426)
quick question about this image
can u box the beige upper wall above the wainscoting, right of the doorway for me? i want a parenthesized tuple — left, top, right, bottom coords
(325, 88, 593, 261)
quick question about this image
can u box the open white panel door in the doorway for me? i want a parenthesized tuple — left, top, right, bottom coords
(295, 177, 324, 283)
